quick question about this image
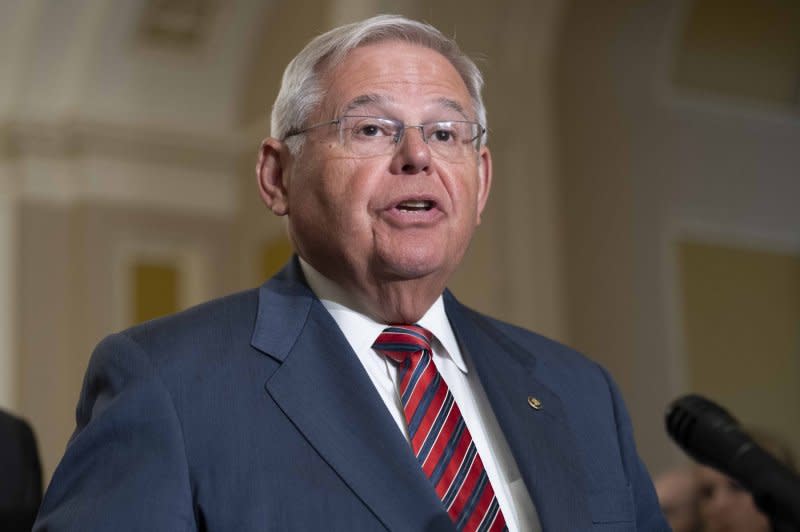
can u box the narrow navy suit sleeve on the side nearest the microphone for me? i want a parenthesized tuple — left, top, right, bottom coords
(600, 367, 670, 531)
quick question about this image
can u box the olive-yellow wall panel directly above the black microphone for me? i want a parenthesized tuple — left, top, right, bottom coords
(679, 242, 800, 450)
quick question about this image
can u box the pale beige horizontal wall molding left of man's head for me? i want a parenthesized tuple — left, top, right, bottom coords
(5, 116, 250, 217)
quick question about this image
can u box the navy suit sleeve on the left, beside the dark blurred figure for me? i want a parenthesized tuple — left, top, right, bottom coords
(34, 335, 197, 532)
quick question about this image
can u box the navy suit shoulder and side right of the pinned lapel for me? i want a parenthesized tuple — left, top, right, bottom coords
(446, 300, 667, 530)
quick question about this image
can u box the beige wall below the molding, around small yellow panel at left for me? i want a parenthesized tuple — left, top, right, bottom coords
(17, 201, 235, 475)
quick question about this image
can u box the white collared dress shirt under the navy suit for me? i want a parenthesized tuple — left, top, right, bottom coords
(300, 259, 541, 532)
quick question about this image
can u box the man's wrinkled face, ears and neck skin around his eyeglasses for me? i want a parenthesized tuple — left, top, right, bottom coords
(257, 41, 491, 323)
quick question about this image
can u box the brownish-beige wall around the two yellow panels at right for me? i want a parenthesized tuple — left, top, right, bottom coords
(558, 0, 800, 471)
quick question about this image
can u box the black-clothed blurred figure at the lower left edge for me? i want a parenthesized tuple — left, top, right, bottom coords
(0, 410, 42, 532)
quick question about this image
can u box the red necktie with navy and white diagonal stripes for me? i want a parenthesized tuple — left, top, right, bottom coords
(372, 325, 506, 532)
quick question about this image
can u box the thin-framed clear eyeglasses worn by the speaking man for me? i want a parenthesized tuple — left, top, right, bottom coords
(284, 115, 486, 161)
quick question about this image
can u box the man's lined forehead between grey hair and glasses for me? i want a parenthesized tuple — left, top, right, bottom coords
(321, 41, 474, 117)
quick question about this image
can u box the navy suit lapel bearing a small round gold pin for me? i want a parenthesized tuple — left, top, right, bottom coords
(445, 292, 591, 530)
